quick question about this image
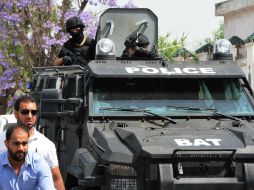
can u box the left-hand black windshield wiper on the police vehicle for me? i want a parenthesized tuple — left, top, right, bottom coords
(100, 107, 177, 124)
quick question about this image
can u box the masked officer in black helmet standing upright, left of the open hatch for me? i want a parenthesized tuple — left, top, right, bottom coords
(54, 16, 96, 66)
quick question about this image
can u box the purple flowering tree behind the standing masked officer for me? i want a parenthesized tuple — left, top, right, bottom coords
(0, 0, 135, 114)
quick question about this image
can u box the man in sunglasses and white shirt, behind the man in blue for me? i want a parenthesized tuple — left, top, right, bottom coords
(0, 96, 65, 190)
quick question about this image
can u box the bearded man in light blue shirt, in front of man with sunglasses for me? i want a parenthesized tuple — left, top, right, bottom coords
(0, 125, 54, 190)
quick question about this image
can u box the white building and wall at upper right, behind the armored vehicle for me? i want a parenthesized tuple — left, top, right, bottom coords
(215, 0, 254, 89)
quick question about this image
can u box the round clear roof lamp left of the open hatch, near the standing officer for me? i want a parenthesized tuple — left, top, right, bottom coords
(96, 38, 115, 58)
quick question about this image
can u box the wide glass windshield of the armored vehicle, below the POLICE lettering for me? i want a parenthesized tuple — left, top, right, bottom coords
(92, 78, 254, 115)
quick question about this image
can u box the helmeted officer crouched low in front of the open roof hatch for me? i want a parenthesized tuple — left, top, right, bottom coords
(122, 34, 157, 59)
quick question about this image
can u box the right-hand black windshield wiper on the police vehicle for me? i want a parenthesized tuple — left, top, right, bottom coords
(166, 106, 241, 122)
